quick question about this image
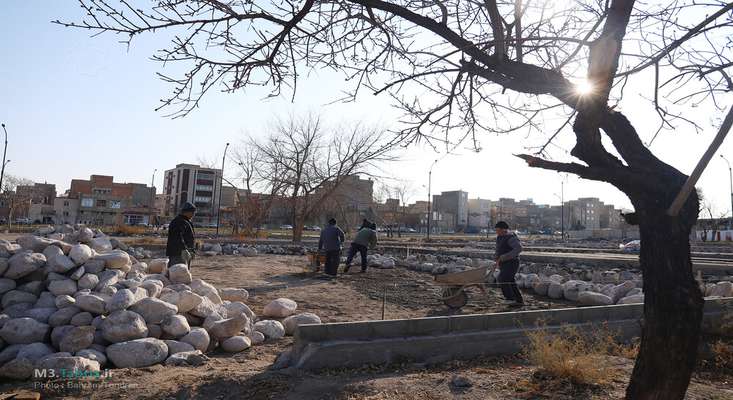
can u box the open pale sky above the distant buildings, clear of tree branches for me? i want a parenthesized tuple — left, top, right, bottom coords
(0, 0, 733, 213)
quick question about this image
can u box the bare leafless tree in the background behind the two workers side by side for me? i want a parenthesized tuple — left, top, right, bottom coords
(251, 115, 392, 242)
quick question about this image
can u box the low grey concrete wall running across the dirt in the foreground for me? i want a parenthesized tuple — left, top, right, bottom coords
(286, 298, 733, 369)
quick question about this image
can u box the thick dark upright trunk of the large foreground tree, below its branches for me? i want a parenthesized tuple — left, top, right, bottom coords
(626, 203, 704, 400)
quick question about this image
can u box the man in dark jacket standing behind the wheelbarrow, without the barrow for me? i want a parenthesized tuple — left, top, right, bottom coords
(494, 221, 524, 307)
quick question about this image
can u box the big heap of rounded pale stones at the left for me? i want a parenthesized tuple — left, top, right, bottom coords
(0, 226, 320, 379)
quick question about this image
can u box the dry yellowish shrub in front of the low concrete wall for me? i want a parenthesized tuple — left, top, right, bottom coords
(524, 326, 638, 385)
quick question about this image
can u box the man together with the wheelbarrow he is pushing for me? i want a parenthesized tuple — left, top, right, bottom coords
(435, 221, 524, 309)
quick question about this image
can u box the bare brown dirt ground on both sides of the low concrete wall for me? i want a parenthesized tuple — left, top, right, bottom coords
(0, 256, 733, 400)
